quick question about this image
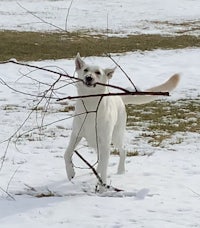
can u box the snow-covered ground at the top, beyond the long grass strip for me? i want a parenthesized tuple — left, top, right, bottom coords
(0, 0, 200, 35)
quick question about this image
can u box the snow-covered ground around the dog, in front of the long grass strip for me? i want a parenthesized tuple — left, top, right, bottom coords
(0, 49, 200, 228)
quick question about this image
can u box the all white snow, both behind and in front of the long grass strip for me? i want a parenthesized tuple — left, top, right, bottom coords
(0, 0, 200, 228)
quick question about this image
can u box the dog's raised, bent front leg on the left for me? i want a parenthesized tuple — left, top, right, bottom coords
(64, 133, 81, 180)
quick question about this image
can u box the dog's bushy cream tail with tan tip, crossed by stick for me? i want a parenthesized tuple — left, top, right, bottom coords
(121, 74, 180, 104)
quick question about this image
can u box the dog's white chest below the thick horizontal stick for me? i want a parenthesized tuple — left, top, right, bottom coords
(76, 99, 117, 148)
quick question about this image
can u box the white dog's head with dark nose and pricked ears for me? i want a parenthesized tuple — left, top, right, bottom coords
(75, 53, 115, 92)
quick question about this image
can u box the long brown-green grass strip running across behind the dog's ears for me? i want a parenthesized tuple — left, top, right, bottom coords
(0, 31, 200, 61)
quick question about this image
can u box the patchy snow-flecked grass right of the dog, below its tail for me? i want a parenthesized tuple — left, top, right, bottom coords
(127, 99, 200, 146)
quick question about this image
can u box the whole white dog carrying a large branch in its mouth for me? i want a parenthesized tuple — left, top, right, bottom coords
(64, 54, 179, 189)
